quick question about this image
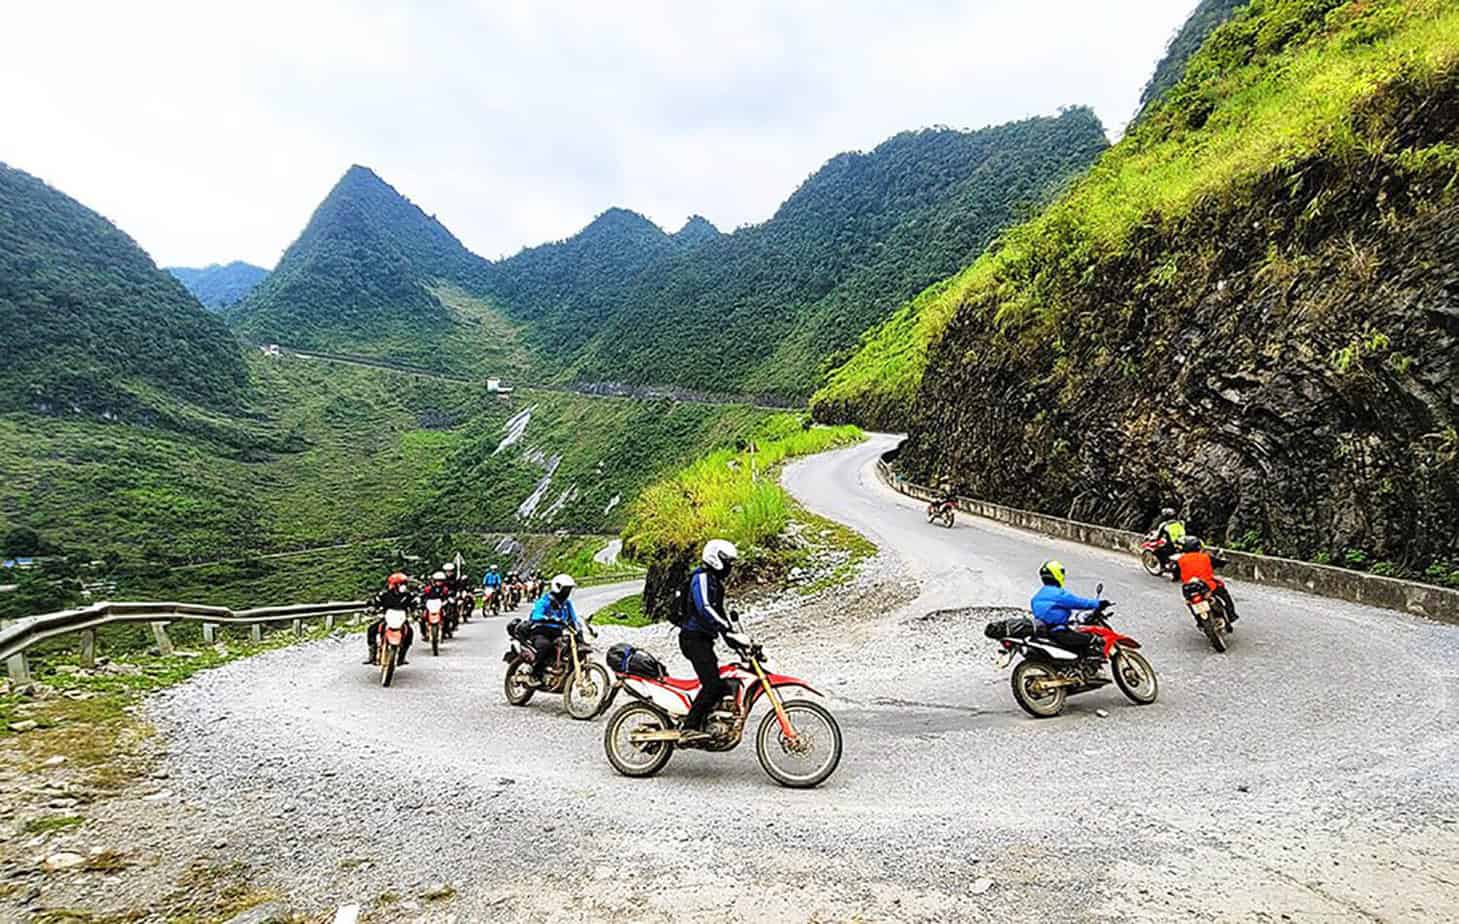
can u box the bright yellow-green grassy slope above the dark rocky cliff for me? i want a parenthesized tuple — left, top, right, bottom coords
(813, 0, 1459, 425)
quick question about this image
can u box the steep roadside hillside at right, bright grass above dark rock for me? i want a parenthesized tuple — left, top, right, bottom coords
(875, 0, 1459, 582)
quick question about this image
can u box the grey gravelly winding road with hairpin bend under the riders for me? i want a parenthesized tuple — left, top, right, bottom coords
(122, 436, 1459, 921)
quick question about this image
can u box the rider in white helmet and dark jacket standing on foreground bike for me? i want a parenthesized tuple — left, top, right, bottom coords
(678, 539, 748, 743)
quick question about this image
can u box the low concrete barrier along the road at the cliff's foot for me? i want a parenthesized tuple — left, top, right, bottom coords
(877, 447, 1459, 625)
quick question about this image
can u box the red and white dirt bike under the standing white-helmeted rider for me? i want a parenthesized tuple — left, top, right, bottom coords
(603, 633, 842, 788)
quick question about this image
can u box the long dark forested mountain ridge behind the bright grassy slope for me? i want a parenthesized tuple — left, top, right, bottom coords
(556, 108, 1107, 396)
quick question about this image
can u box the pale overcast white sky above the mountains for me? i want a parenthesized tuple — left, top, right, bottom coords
(0, 0, 1196, 267)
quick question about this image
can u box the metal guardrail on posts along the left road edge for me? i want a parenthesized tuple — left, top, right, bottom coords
(0, 600, 366, 683)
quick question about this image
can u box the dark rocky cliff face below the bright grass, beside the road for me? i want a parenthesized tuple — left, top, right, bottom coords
(903, 74, 1459, 580)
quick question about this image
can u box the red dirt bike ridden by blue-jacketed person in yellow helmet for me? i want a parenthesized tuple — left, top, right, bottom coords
(988, 584, 1160, 718)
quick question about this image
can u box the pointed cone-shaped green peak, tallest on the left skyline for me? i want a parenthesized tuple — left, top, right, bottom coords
(226, 166, 492, 368)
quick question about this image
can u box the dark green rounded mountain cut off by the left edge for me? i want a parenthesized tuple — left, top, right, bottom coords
(0, 163, 245, 419)
